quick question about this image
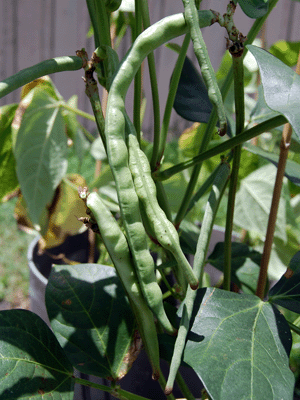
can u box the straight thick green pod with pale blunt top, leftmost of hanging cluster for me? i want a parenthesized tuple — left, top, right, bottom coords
(86, 192, 159, 378)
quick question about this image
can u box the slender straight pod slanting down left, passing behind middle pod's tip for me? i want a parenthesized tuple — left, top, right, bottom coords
(165, 163, 230, 395)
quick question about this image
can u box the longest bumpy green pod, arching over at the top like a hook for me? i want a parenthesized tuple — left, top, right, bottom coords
(105, 11, 214, 336)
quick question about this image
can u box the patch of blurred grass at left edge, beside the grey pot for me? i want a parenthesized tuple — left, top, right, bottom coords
(0, 199, 33, 308)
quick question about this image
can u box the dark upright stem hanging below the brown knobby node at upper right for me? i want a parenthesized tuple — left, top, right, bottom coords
(223, 57, 245, 290)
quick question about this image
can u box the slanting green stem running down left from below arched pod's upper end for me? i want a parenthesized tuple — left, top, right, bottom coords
(150, 33, 191, 171)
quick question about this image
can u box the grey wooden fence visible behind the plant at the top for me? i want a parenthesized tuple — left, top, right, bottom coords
(0, 0, 300, 135)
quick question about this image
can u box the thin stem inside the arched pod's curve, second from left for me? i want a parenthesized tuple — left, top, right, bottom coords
(140, 0, 160, 159)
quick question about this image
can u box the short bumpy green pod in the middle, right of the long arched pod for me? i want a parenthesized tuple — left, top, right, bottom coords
(128, 134, 199, 290)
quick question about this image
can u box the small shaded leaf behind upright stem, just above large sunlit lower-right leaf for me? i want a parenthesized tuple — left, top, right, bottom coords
(207, 242, 261, 294)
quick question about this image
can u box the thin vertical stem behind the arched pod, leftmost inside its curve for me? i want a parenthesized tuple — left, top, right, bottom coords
(133, 0, 143, 143)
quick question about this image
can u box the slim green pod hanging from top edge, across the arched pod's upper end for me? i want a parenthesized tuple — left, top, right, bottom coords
(182, 0, 227, 136)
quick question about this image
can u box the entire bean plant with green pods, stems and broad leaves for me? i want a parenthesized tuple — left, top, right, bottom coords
(0, 0, 300, 400)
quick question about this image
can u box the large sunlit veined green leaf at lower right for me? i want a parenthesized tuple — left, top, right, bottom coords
(179, 288, 294, 400)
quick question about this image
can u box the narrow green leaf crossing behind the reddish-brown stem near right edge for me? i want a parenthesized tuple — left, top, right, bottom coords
(244, 143, 300, 186)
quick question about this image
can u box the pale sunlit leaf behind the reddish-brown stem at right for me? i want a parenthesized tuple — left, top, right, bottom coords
(234, 164, 286, 241)
